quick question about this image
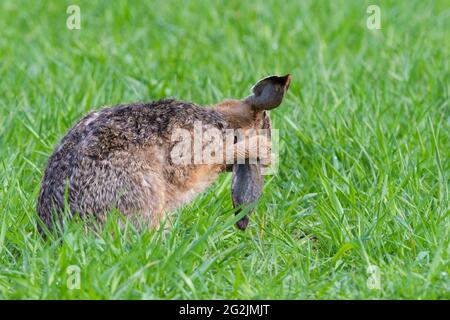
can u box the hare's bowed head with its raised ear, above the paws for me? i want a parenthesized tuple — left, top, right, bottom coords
(214, 74, 291, 129)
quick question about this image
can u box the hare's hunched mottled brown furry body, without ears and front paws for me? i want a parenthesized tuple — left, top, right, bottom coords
(37, 76, 290, 234)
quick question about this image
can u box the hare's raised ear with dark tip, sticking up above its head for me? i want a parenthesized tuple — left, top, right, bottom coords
(245, 74, 291, 110)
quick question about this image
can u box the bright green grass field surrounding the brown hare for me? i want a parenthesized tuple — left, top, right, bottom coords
(0, 0, 450, 299)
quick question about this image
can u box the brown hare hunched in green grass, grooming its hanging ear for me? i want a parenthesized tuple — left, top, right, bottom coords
(37, 75, 290, 231)
